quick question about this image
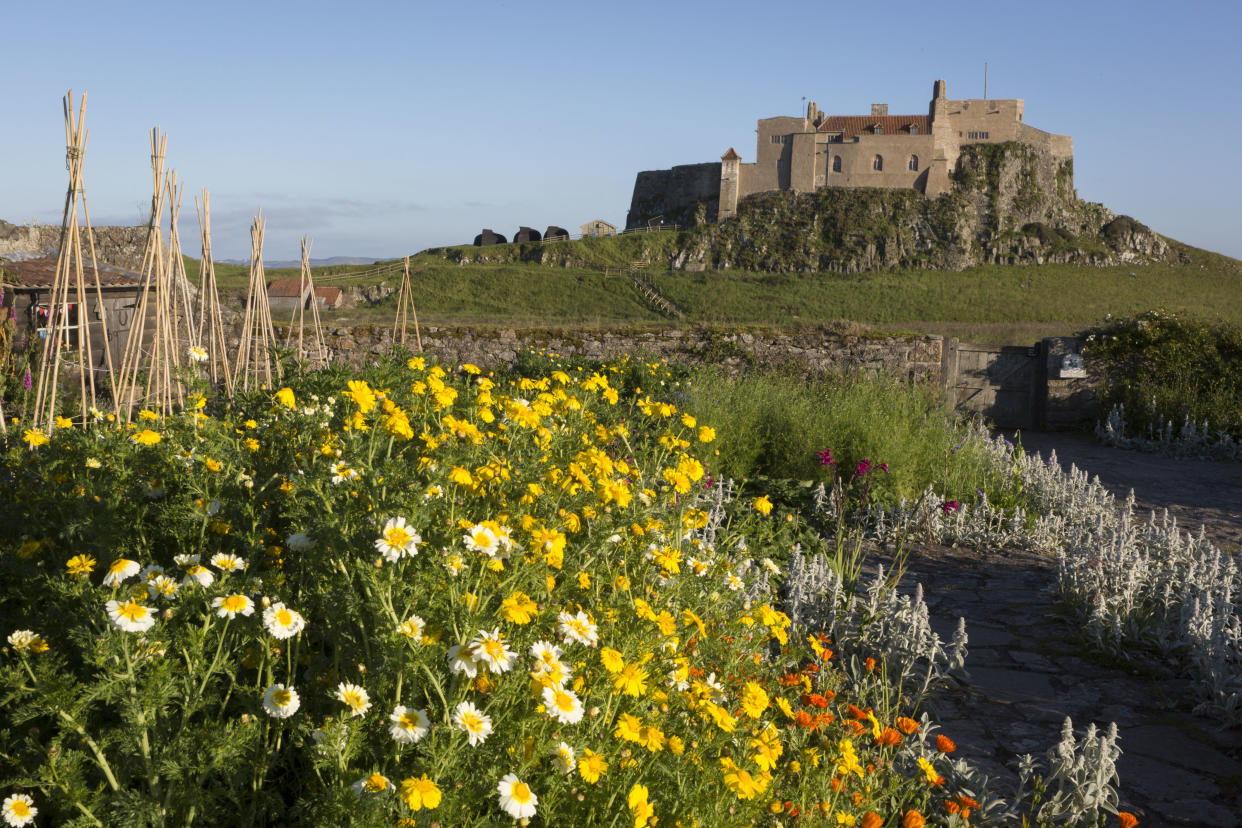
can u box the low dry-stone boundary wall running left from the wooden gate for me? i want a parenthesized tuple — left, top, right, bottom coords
(269, 325, 944, 385)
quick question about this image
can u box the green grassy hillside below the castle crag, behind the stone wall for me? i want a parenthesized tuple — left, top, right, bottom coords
(183, 232, 1242, 344)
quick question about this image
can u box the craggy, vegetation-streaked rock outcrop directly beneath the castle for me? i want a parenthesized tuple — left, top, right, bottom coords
(671, 143, 1177, 273)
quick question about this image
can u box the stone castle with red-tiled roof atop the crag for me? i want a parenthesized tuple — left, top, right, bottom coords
(626, 81, 1074, 227)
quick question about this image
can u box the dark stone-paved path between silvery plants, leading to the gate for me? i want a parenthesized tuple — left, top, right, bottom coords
(884, 434, 1242, 828)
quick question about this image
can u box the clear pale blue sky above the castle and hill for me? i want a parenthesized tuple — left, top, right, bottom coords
(0, 0, 1242, 258)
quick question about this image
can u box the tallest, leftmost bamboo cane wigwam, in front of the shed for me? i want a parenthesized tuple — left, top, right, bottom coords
(32, 89, 113, 431)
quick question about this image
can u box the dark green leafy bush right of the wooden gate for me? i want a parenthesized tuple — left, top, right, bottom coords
(1084, 310, 1242, 439)
